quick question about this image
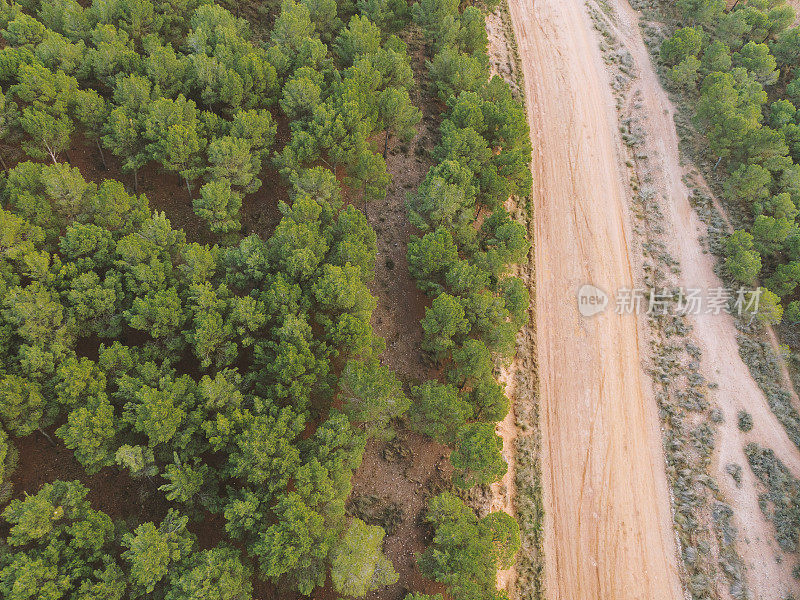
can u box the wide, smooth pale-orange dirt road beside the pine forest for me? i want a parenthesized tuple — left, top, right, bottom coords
(509, 0, 683, 600)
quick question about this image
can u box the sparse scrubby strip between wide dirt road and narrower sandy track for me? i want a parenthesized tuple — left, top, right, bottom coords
(588, 3, 748, 599)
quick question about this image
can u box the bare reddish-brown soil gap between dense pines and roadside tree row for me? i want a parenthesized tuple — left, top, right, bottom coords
(336, 33, 450, 600)
